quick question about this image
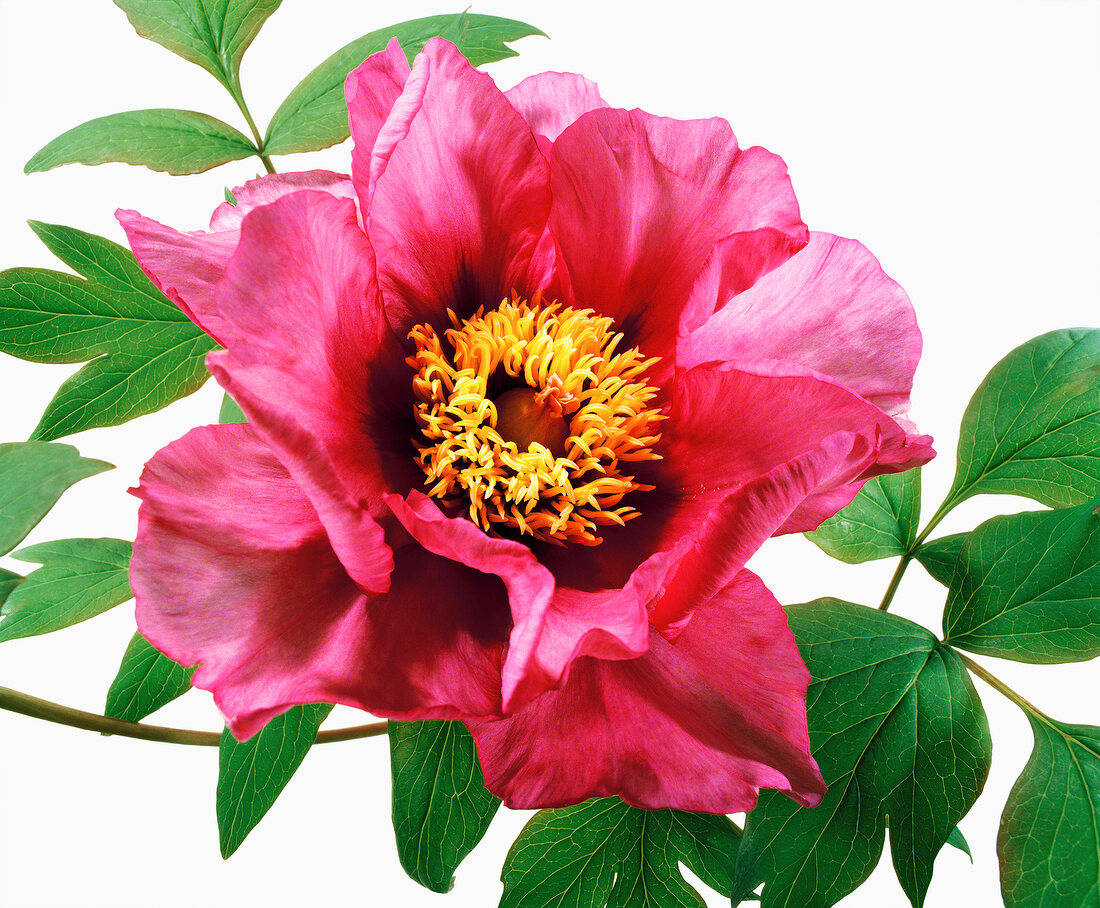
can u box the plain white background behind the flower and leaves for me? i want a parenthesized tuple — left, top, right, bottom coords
(0, 0, 1100, 908)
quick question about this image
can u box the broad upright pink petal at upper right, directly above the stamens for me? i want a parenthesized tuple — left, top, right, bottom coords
(550, 109, 807, 367)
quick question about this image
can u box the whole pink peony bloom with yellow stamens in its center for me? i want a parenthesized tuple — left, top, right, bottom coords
(119, 40, 933, 813)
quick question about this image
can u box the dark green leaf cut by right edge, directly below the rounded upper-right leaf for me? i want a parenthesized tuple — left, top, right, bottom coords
(944, 499, 1100, 663)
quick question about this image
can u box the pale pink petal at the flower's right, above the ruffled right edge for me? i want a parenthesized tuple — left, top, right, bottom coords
(678, 233, 921, 416)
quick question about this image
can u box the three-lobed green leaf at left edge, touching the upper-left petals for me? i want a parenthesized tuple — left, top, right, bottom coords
(0, 221, 215, 440)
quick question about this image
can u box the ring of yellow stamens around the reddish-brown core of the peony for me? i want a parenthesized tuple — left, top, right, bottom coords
(407, 294, 664, 546)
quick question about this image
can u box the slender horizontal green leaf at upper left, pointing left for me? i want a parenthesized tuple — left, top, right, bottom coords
(23, 108, 257, 175)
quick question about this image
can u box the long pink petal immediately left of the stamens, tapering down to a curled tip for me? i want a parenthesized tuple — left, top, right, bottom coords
(208, 192, 414, 580)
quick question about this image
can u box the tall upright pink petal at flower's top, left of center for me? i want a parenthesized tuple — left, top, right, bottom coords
(349, 39, 550, 336)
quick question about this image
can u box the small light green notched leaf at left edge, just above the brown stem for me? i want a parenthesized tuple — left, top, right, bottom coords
(0, 539, 133, 643)
